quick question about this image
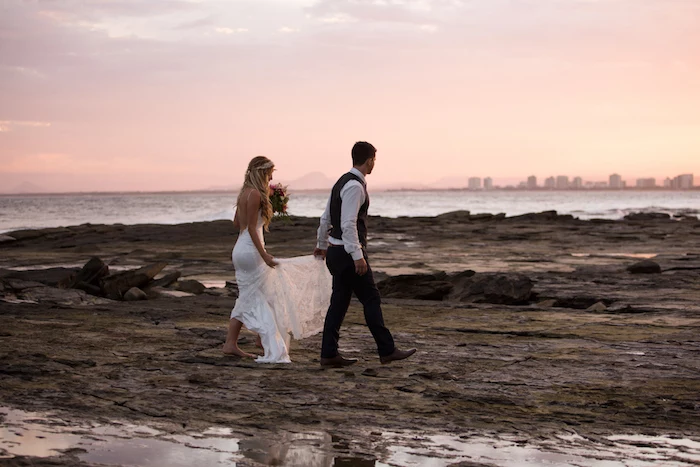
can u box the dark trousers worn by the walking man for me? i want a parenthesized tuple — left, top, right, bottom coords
(321, 246, 394, 358)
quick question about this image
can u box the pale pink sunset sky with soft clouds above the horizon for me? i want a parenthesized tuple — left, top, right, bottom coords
(0, 0, 700, 192)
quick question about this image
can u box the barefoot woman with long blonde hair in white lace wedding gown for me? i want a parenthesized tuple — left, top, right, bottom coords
(223, 156, 332, 363)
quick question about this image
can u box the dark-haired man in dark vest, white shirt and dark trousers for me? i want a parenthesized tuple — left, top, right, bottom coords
(314, 141, 416, 367)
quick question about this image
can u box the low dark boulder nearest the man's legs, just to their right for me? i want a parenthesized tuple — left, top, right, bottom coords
(377, 272, 454, 300)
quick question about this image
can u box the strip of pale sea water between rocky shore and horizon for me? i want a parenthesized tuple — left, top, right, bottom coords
(0, 190, 700, 232)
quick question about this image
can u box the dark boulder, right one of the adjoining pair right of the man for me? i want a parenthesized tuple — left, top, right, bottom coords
(447, 271, 534, 305)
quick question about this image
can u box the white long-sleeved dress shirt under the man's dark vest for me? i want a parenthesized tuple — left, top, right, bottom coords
(316, 167, 367, 261)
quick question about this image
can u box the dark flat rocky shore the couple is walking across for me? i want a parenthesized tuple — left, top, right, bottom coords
(0, 211, 700, 466)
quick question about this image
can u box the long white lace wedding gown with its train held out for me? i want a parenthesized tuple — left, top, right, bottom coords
(231, 212, 332, 363)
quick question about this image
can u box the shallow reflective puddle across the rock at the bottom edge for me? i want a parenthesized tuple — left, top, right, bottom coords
(0, 408, 700, 467)
